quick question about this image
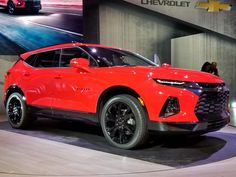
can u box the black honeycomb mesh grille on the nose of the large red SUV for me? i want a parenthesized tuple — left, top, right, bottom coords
(195, 91, 229, 115)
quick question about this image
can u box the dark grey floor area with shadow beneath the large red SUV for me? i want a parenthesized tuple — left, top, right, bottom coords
(0, 119, 236, 167)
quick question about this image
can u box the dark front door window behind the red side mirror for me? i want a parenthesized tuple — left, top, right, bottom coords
(60, 47, 96, 67)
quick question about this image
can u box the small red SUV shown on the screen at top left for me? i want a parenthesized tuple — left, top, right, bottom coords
(0, 0, 42, 14)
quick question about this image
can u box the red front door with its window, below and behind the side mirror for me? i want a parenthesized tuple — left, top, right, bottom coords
(52, 47, 95, 112)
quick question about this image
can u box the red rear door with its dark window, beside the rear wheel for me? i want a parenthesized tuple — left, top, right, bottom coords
(22, 49, 61, 110)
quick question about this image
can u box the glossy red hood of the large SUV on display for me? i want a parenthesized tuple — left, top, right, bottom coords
(110, 66, 224, 83)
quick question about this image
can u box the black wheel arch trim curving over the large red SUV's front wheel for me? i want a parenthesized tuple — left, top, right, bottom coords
(97, 86, 148, 121)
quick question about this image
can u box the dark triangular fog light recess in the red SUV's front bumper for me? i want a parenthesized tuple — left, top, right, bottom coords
(160, 97, 180, 118)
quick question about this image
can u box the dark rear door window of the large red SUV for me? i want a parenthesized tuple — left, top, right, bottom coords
(33, 50, 61, 68)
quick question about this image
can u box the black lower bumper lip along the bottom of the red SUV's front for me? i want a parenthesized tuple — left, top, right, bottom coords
(148, 112, 230, 134)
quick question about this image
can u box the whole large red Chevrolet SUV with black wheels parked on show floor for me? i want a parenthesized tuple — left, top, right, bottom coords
(4, 43, 230, 149)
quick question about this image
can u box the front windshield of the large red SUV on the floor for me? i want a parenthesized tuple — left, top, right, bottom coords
(81, 46, 157, 67)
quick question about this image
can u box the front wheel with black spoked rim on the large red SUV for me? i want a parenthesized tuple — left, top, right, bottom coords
(100, 94, 148, 149)
